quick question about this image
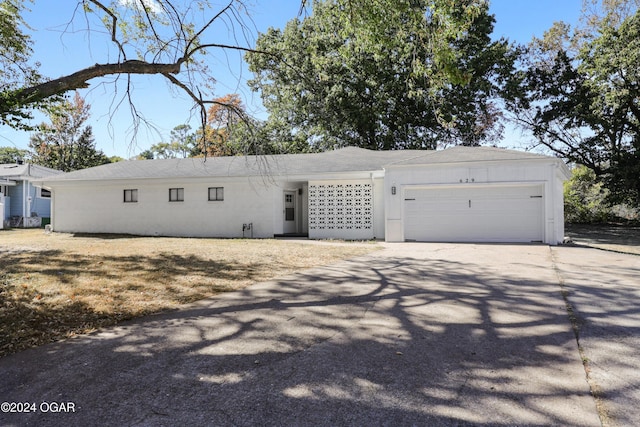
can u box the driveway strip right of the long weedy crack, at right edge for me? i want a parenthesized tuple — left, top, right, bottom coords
(552, 247, 640, 425)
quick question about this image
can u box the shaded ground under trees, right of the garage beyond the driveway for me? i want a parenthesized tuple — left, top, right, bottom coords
(565, 224, 640, 255)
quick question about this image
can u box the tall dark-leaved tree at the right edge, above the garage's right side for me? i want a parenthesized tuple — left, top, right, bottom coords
(508, 0, 640, 206)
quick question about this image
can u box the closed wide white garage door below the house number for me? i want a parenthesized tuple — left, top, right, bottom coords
(404, 185, 544, 242)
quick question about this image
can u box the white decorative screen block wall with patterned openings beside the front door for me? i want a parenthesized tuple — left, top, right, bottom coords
(309, 181, 373, 239)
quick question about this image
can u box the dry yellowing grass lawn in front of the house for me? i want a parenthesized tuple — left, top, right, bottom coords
(0, 229, 379, 356)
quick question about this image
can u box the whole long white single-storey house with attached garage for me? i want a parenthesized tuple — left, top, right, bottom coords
(39, 147, 569, 244)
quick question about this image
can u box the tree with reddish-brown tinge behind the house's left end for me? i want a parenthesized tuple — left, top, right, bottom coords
(29, 93, 110, 172)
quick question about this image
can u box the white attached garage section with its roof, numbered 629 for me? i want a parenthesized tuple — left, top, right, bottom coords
(385, 147, 569, 245)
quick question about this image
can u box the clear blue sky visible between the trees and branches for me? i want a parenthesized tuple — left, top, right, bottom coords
(0, 0, 582, 158)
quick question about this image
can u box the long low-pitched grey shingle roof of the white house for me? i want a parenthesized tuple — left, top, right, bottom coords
(40, 147, 560, 182)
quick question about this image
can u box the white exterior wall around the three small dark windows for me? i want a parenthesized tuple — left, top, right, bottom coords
(52, 179, 279, 237)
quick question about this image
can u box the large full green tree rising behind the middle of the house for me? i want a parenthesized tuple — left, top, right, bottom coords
(246, 0, 513, 150)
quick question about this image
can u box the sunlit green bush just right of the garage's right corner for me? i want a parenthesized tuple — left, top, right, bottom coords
(564, 165, 612, 223)
